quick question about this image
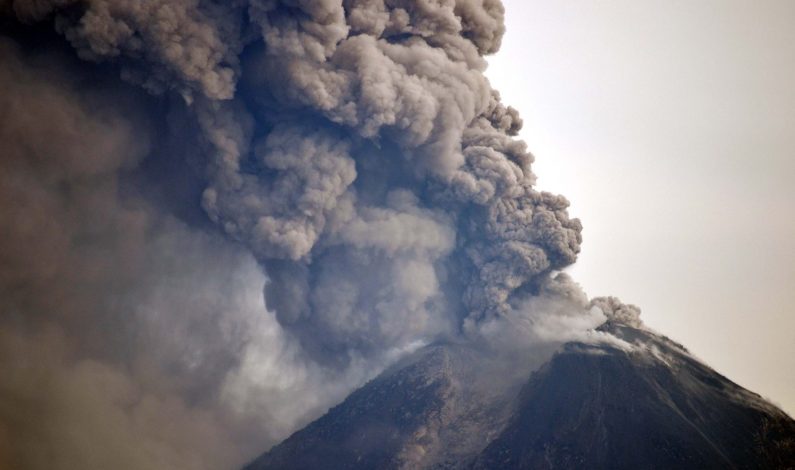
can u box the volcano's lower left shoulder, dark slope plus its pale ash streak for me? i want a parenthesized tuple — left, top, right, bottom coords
(246, 344, 529, 470)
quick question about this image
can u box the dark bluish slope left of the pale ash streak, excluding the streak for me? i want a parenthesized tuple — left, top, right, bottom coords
(247, 348, 452, 469)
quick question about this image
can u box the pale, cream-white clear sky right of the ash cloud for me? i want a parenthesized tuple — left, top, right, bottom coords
(487, 0, 795, 415)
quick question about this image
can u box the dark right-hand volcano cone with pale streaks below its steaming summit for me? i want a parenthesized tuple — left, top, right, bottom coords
(475, 325, 795, 469)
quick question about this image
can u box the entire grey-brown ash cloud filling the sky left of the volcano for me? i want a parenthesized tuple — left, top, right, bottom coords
(0, 0, 637, 469)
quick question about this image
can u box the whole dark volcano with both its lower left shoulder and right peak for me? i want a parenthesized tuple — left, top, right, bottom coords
(247, 323, 795, 470)
